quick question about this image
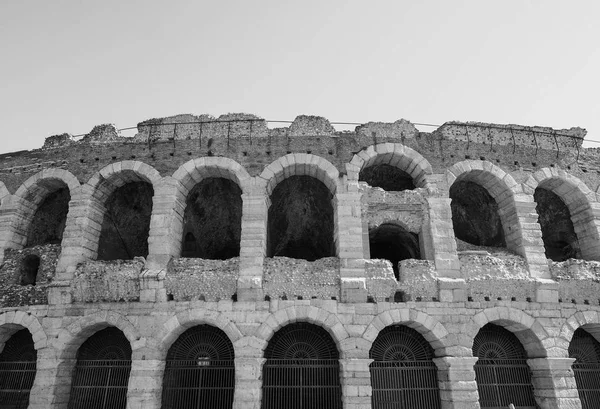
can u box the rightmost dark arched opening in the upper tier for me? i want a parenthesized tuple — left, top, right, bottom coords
(533, 187, 581, 261)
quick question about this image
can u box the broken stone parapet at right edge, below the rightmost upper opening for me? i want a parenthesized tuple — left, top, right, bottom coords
(550, 259, 600, 305)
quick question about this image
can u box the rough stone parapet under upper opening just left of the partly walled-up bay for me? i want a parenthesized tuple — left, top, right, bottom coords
(263, 257, 340, 300)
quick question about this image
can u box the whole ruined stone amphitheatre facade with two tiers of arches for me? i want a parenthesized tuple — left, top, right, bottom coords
(0, 114, 600, 409)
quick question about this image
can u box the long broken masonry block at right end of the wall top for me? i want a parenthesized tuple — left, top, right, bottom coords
(434, 121, 587, 150)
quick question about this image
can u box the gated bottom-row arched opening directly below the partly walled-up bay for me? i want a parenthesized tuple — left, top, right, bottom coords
(369, 325, 441, 409)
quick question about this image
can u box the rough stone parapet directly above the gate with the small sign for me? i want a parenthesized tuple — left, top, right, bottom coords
(164, 257, 240, 301)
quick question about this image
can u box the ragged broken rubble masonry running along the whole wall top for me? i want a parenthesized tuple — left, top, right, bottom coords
(38, 113, 586, 150)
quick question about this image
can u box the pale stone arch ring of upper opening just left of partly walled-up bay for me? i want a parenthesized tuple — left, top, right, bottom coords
(259, 153, 340, 196)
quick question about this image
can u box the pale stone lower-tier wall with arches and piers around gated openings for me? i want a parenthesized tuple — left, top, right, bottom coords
(0, 299, 600, 409)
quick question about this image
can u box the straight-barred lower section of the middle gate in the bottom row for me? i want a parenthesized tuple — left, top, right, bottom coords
(262, 359, 342, 409)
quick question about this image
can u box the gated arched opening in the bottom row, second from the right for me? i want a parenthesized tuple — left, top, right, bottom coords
(473, 324, 537, 409)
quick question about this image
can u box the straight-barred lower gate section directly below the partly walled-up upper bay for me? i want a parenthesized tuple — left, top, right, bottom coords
(370, 361, 440, 409)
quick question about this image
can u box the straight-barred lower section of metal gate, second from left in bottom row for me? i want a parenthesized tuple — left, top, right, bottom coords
(69, 360, 131, 409)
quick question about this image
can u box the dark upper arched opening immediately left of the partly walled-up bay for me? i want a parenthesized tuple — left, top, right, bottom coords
(267, 176, 335, 261)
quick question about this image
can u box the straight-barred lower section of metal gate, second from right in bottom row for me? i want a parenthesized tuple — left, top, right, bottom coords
(475, 359, 536, 409)
